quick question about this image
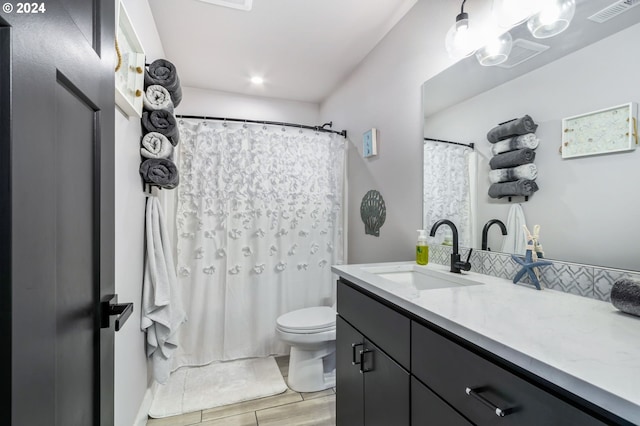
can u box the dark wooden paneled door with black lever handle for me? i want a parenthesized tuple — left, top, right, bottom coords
(0, 0, 115, 426)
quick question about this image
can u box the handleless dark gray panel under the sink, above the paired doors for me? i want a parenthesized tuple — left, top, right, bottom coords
(338, 281, 411, 370)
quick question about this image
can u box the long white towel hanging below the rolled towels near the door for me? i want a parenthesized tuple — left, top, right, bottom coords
(140, 197, 186, 383)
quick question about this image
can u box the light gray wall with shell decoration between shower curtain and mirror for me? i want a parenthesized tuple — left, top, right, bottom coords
(321, 0, 490, 263)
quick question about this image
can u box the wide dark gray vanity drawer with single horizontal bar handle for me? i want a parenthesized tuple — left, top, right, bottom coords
(411, 322, 605, 426)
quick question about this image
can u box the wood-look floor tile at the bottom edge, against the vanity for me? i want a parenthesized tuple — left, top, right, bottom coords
(256, 395, 336, 426)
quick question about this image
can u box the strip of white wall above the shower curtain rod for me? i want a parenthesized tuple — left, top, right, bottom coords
(176, 86, 323, 126)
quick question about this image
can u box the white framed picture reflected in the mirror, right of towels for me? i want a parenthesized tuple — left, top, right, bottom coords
(561, 102, 638, 158)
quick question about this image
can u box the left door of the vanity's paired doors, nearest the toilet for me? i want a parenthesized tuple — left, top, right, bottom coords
(336, 316, 364, 426)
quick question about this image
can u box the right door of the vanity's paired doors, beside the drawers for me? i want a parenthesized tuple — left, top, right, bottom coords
(362, 340, 410, 426)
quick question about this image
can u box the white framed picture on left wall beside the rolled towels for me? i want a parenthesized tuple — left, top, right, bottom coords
(115, 1, 145, 118)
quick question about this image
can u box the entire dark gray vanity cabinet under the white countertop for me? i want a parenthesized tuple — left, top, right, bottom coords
(336, 278, 631, 426)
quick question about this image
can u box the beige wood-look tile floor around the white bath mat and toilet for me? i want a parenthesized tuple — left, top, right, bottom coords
(147, 356, 336, 426)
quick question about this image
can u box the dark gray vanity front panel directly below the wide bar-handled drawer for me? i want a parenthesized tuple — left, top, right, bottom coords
(411, 377, 473, 426)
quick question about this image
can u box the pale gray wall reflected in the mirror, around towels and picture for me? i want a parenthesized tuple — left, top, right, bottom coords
(425, 24, 640, 270)
